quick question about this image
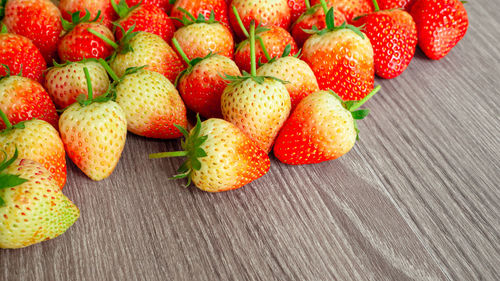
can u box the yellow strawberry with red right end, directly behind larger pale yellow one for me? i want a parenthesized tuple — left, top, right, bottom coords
(110, 28, 184, 83)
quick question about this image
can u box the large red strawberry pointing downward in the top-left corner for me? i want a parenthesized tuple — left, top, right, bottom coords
(3, 0, 62, 63)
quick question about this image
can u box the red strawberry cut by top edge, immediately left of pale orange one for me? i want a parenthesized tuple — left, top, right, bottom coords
(171, 0, 230, 28)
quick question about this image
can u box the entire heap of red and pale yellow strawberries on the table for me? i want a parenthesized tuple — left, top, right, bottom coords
(0, 0, 468, 248)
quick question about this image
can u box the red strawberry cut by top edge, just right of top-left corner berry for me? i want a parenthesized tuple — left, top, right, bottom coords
(59, 0, 117, 28)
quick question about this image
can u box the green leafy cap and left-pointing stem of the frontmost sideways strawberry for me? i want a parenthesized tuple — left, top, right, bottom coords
(149, 114, 208, 187)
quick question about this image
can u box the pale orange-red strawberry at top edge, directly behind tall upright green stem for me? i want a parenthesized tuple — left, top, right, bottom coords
(229, 0, 292, 38)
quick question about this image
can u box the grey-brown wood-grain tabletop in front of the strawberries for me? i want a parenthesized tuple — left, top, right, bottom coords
(0, 0, 500, 281)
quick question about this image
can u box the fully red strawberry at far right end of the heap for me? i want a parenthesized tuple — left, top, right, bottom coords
(411, 0, 469, 60)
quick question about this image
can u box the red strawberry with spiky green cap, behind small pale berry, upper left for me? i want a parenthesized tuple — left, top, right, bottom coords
(57, 11, 115, 61)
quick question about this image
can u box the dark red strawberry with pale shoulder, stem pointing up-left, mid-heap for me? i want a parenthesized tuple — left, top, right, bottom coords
(172, 38, 241, 118)
